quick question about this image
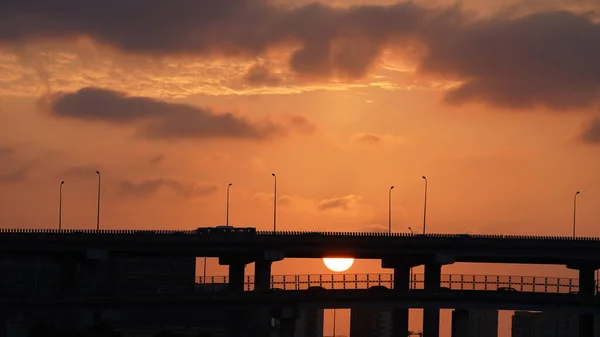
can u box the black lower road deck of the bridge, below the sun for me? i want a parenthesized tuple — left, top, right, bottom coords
(0, 289, 600, 314)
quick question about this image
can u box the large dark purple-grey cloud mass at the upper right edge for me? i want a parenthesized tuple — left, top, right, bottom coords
(421, 12, 600, 110)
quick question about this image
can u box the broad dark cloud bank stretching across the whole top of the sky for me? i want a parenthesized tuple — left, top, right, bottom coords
(0, 0, 600, 109)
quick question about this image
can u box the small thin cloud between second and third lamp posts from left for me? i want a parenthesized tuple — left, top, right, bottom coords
(119, 179, 217, 198)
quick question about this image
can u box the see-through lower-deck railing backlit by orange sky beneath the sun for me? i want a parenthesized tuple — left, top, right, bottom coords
(197, 274, 592, 293)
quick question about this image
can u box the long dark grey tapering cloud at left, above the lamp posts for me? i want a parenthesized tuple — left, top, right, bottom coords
(42, 88, 287, 140)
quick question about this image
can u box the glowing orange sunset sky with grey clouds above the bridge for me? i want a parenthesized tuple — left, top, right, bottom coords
(0, 0, 600, 334)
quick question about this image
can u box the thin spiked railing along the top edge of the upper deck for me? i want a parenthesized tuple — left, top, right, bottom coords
(0, 228, 600, 242)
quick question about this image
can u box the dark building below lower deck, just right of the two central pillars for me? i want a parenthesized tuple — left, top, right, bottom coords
(452, 309, 498, 337)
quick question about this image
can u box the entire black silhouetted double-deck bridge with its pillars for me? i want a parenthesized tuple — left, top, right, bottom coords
(0, 229, 600, 337)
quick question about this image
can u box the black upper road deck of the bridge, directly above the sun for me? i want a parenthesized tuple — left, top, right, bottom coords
(0, 229, 600, 265)
